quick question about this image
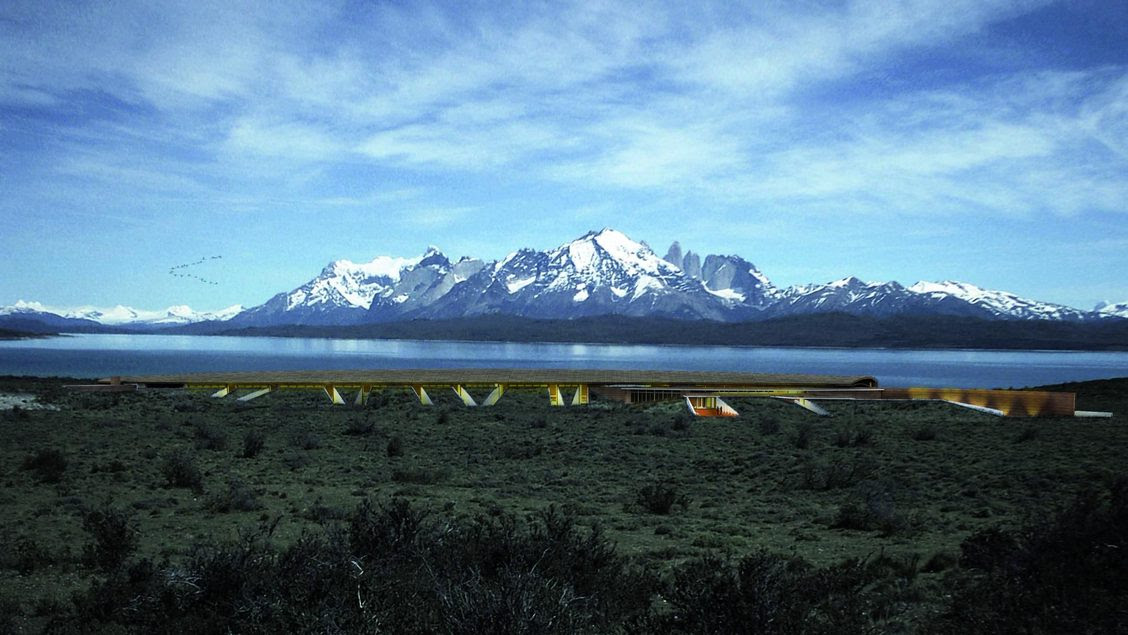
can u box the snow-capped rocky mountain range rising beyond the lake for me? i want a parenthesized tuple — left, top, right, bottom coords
(0, 229, 1128, 332)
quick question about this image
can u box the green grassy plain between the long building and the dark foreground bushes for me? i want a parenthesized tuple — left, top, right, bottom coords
(0, 378, 1128, 632)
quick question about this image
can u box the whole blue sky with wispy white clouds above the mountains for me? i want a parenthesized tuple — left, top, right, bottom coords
(0, 0, 1128, 309)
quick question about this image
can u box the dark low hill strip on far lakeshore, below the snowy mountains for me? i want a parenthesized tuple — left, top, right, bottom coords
(198, 314, 1128, 351)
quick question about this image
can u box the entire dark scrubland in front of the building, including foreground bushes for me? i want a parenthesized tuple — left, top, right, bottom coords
(0, 379, 1128, 633)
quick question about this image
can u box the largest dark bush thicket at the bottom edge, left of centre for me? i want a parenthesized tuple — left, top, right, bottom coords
(61, 500, 656, 633)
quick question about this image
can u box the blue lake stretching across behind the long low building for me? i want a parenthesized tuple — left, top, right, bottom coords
(0, 335, 1128, 388)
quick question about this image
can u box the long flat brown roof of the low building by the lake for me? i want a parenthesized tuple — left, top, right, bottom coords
(107, 368, 878, 388)
